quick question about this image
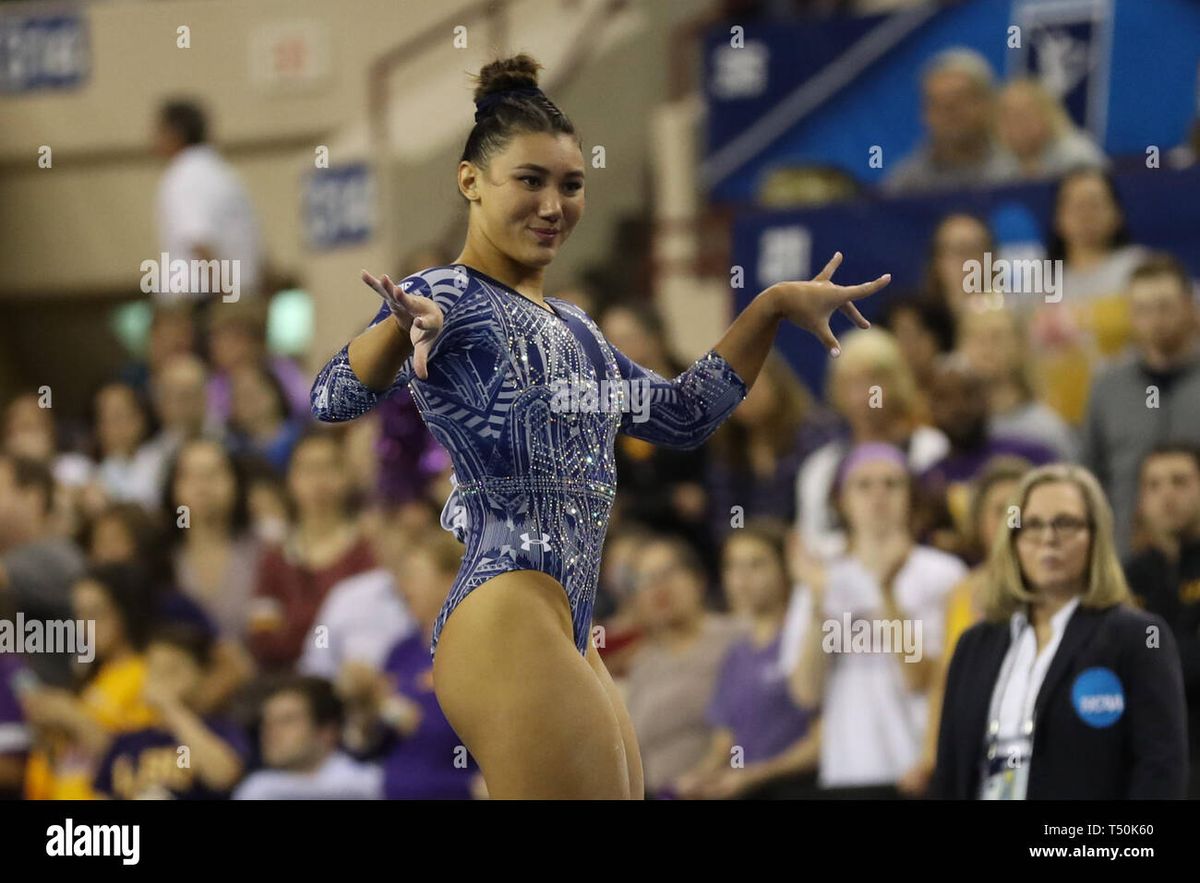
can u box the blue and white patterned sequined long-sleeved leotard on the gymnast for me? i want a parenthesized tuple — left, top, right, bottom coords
(311, 264, 746, 655)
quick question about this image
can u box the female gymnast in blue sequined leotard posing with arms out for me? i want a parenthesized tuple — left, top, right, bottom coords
(312, 54, 890, 798)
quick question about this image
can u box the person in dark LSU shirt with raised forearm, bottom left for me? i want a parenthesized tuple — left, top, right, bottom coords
(94, 625, 250, 800)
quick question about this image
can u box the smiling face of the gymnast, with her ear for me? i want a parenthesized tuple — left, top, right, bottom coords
(458, 132, 583, 266)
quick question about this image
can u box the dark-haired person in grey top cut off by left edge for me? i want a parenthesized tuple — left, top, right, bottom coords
(0, 453, 84, 686)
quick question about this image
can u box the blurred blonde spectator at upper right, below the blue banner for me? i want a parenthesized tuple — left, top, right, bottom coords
(996, 78, 1106, 179)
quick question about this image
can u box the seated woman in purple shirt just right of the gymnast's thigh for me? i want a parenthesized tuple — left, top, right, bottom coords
(677, 521, 822, 799)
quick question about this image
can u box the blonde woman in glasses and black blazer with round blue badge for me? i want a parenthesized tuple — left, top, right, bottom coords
(932, 463, 1188, 800)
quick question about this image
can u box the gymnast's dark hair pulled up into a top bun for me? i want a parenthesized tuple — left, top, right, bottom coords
(460, 53, 578, 179)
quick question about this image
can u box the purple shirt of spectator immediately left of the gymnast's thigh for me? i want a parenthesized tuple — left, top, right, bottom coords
(383, 630, 479, 800)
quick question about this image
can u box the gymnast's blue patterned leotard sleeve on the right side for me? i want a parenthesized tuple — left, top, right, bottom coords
(613, 347, 746, 450)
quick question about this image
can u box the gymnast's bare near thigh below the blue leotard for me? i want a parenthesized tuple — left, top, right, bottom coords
(433, 570, 640, 799)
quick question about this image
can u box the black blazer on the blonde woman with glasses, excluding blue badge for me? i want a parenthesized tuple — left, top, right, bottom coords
(930, 605, 1188, 800)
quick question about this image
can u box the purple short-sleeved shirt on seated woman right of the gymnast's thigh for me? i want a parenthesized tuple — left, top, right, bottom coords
(708, 631, 812, 763)
